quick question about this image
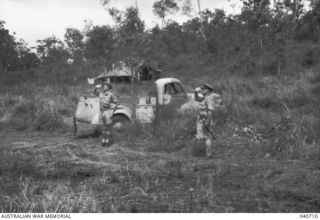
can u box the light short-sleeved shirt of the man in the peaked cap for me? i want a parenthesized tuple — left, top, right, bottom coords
(198, 93, 222, 116)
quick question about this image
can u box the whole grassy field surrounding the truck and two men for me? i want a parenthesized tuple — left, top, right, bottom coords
(0, 71, 320, 212)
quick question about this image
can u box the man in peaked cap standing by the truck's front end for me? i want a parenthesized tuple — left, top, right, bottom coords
(195, 83, 222, 159)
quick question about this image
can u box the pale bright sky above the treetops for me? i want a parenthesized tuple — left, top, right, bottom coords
(0, 0, 240, 47)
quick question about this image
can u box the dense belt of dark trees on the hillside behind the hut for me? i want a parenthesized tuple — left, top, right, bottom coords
(1, 0, 320, 78)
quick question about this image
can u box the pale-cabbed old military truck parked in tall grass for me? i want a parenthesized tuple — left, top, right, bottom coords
(74, 78, 197, 135)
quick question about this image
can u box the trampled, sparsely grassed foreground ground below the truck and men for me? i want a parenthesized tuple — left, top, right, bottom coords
(0, 133, 320, 212)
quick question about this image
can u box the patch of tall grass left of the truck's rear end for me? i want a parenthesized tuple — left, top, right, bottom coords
(0, 84, 81, 131)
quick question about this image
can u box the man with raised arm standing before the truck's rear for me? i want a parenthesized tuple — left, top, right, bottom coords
(93, 82, 117, 146)
